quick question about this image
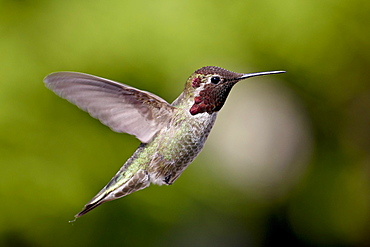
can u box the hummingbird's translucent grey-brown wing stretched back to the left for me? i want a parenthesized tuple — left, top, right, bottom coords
(44, 72, 174, 143)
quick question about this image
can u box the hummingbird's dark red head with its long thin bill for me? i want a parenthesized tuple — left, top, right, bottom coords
(187, 66, 285, 115)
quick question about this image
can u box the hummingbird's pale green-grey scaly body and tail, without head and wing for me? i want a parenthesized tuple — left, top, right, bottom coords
(77, 108, 217, 216)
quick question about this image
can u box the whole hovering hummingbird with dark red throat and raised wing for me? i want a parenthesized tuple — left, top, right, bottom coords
(44, 66, 285, 219)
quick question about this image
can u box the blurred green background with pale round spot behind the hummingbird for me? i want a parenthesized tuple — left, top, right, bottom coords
(0, 0, 370, 247)
